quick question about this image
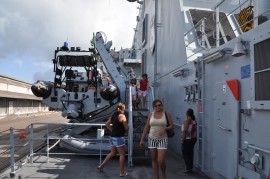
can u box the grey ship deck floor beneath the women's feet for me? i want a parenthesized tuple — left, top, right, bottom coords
(0, 148, 208, 179)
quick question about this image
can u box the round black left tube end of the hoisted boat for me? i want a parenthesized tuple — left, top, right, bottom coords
(31, 80, 53, 99)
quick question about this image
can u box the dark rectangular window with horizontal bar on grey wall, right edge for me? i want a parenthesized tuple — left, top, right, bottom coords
(254, 39, 270, 101)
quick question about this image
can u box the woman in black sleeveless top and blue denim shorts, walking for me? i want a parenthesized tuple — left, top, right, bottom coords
(98, 103, 128, 177)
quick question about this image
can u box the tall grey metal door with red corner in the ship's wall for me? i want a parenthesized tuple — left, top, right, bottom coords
(213, 80, 239, 179)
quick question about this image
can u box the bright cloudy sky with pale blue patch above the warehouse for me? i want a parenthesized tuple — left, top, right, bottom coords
(0, 0, 139, 83)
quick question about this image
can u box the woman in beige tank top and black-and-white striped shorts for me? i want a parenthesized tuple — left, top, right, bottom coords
(140, 99, 174, 179)
